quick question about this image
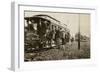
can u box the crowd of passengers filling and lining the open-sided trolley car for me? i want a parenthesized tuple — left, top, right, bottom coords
(24, 18, 73, 48)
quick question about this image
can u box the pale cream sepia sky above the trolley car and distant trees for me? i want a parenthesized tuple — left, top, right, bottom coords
(24, 11, 90, 37)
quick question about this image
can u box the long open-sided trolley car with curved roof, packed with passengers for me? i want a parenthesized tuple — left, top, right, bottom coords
(24, 14, 70, 51)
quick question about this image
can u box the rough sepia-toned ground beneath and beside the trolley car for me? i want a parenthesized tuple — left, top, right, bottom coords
(24, 41, 90, 61)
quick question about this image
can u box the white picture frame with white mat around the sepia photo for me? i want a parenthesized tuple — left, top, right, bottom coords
(11, 2, 97, 71)
